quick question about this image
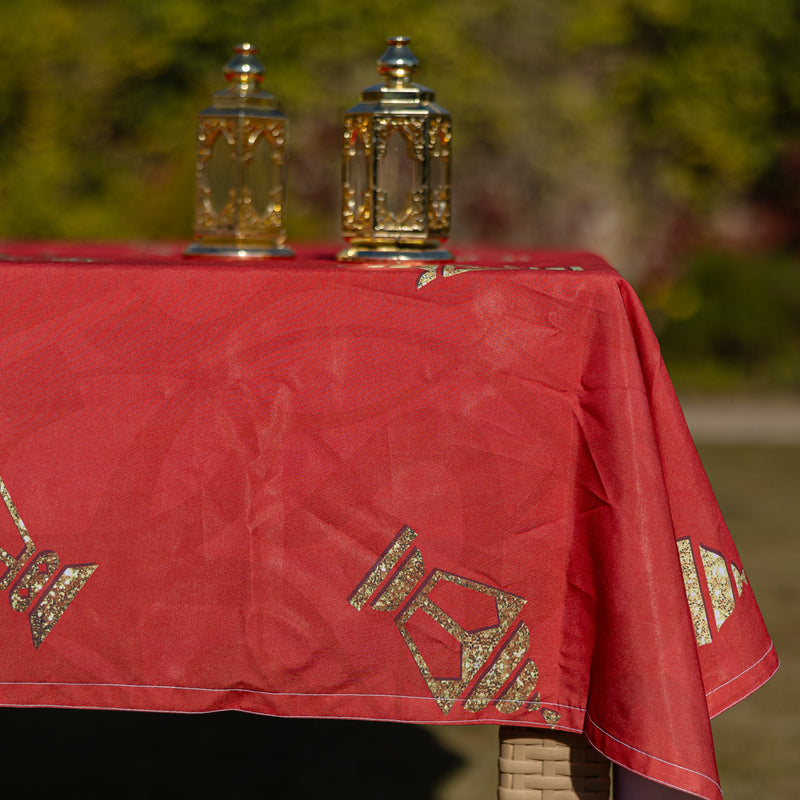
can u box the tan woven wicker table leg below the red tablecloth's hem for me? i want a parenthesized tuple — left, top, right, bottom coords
(497, 726, 611, 800)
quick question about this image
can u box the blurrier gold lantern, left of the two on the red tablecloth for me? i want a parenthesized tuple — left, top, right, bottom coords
(186, 44, 294, 258)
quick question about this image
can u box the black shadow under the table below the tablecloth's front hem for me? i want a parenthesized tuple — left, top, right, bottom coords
(0, 708, 461, 800)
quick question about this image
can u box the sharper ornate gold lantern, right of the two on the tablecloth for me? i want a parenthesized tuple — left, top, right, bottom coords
(339, 36, 452, 261)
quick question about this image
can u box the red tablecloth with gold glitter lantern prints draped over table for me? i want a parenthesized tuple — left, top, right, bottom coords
(0, 242, 777, 798)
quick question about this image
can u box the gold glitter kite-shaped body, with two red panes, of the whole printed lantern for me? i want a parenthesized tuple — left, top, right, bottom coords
(395, 569, 525, 714)
